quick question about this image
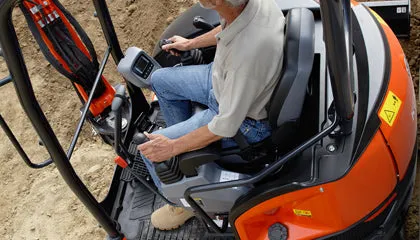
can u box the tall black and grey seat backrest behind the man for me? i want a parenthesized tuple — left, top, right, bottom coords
(268, 8, 315, 146)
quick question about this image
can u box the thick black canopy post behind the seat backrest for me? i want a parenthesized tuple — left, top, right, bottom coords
(320, 0, 354, 134)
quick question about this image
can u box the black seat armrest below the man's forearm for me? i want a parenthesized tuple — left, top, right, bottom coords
(178, 144, 220, 177)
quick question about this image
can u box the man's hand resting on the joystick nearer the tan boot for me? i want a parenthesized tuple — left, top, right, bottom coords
(137, 133, 176, 162)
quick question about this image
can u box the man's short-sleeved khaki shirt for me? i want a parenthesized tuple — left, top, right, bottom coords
(208, 0, 285, 137)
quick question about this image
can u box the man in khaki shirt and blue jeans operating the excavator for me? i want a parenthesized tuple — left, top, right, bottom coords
(138, 0, 285, 230)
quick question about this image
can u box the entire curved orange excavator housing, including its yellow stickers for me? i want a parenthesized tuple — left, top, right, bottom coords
(235, 8, 417, 240)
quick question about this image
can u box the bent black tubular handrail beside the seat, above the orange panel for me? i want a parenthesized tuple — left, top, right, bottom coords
(184, 116, 339, 233)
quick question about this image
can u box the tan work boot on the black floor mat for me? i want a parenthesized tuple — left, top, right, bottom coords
(151, 204, 194, 230)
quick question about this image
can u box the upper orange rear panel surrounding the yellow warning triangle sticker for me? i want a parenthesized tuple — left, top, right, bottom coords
(375, 12, 417, 178)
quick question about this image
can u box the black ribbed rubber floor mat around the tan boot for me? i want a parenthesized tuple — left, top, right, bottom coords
(118, 181, 233, 240)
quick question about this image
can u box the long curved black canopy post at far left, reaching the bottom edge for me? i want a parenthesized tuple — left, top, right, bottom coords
(0, 0, 122, 238)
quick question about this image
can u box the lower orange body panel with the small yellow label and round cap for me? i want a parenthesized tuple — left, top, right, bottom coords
(235, 132, 397, 240)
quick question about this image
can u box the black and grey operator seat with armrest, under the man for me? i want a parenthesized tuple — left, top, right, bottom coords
(158, 8, 315, 179)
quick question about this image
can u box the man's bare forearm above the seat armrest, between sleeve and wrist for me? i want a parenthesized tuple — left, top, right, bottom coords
(174, 126, 223, 155)
